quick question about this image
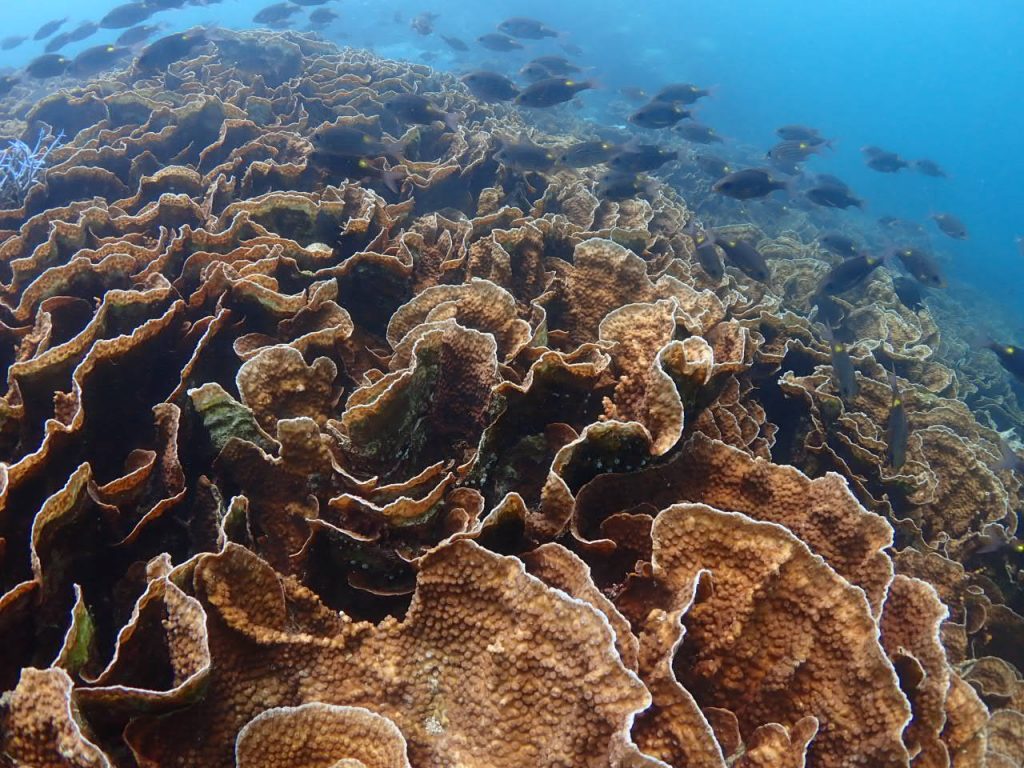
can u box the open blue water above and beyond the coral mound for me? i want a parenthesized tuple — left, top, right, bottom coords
(0, 0, 1024, 329)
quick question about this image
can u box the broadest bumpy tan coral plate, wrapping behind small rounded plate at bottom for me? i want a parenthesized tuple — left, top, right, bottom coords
(129, 541, 649, 768)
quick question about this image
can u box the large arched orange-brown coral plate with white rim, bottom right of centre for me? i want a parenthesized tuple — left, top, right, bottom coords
(638, 505, 910, 766)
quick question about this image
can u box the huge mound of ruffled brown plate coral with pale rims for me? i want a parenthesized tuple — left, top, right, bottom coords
(0, 33, 1024, 768)
